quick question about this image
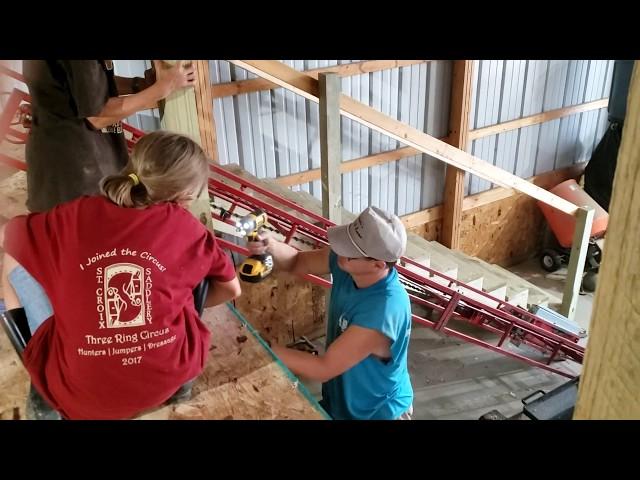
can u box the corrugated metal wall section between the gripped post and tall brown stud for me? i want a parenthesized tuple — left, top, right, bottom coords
(210, 60, 451, 215)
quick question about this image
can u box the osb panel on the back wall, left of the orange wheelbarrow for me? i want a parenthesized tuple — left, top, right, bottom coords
(460, 194, 545, 267)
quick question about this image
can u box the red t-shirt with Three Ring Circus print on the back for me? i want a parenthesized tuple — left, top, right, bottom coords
(4, 196, 235, 419)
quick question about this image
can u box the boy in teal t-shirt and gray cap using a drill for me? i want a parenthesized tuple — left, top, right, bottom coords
(247, 207, 413, 420)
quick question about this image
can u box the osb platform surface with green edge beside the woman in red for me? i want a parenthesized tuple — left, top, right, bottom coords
(140, 305, 324, 420)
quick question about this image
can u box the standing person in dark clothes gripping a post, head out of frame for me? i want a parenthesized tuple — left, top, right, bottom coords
(22, 60, 195, 212)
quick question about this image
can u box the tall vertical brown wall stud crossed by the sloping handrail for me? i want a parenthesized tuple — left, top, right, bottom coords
(441, 60, 473, 250)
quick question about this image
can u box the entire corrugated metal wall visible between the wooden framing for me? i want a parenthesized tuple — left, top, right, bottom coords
(116, 60, 614, 215)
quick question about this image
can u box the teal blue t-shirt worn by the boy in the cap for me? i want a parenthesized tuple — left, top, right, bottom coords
(322, 252, 413, 420)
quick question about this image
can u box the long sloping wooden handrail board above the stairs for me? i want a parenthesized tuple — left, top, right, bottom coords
(229, 60, 578, 215)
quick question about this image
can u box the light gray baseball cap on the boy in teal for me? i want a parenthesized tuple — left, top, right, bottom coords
(327, 207, 407, 262)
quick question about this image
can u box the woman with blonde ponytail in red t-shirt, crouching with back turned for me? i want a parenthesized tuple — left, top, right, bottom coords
(3, 132, 240, 419)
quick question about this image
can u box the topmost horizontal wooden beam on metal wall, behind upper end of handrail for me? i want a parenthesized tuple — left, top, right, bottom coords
(211, 60, 429, 98)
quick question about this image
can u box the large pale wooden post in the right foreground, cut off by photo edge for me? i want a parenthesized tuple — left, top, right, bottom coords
(574, 61, 640, 420)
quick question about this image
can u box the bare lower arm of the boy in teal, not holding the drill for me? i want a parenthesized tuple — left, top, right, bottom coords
(273, 325, 390, 383)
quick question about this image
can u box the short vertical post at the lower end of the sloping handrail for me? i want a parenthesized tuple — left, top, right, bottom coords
(560, 207, 595, 320)
